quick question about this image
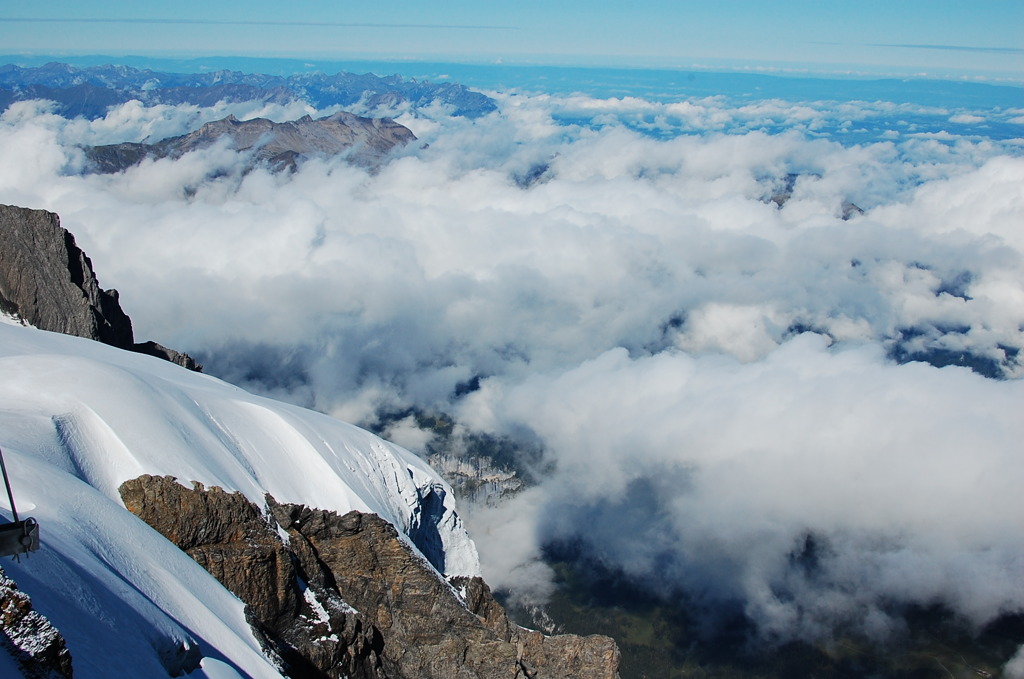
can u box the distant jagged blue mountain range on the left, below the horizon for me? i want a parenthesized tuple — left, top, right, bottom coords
(0, 62, 497, 120)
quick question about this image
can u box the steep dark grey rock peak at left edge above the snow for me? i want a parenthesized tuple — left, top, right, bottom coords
(0, 205, 201, 370)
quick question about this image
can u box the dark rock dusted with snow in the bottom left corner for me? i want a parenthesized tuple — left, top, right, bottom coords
(0, 568, 73, 679)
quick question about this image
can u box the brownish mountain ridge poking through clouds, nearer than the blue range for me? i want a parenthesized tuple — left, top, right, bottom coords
(85, 112, 416, 173)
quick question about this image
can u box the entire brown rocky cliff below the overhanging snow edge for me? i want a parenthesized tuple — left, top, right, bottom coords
(120, 476, 618, 679)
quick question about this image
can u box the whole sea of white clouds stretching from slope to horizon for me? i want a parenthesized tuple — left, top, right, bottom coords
(0, 86, 1024, 663)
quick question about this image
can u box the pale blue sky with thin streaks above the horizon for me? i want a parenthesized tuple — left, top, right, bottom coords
(0, 0, 1024, 81)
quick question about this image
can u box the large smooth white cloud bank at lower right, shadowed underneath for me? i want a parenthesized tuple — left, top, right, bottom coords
(463, 335, 1024, 637)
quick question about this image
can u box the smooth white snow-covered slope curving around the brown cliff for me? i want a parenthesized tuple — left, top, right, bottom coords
(0, 321, 478, 679)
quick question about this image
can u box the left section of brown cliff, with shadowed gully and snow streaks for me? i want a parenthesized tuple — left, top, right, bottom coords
(120, 475, 388, 679)
